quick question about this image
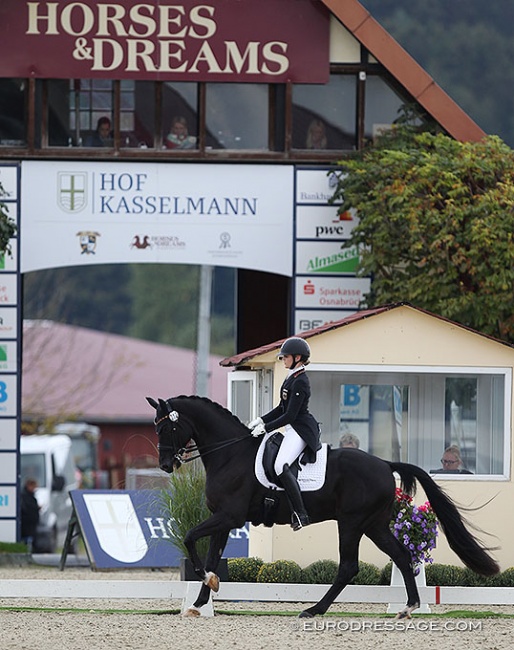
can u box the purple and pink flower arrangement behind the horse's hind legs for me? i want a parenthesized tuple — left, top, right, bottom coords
(391, 488, 438, 575)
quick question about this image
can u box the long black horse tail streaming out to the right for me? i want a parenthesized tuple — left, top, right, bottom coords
(388, 462, 500, 576)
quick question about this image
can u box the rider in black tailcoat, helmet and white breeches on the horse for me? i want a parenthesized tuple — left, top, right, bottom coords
(248, 336, 321, 530)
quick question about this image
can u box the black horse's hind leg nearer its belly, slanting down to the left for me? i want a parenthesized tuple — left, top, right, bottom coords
(300, 517, 363, 618)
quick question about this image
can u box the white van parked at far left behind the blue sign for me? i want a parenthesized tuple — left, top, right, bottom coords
(20, 435, 78, 553)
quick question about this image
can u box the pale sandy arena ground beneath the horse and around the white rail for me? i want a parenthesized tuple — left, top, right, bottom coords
(0, 565, 514, 650)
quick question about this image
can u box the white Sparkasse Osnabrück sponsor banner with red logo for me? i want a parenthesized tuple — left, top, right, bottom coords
(295, 276, 370, 310)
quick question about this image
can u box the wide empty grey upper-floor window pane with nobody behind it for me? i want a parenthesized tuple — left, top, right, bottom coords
(205, 83, 269, 150)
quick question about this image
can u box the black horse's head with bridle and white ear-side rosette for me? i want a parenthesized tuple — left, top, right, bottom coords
(146, 397, 193, 474)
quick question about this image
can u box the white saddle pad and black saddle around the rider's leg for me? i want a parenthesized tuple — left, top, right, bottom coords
(255, 431, 328, 492)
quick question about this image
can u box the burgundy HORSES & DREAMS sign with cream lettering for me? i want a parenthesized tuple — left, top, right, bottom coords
(0, 0, 329, 83)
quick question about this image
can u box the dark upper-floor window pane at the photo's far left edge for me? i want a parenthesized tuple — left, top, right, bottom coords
(0, 79, 27, 147)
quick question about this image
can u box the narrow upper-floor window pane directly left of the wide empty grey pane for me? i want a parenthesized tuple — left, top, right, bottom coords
(162, 82, 198, 149)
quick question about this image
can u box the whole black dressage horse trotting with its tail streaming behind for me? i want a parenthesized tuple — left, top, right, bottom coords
(147, 396, 499, 618)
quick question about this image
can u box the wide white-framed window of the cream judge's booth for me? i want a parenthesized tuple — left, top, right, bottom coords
(309, 366, 510, 478)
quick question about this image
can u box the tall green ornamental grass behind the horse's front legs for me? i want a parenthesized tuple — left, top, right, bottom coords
(159, 461, 211, 560)
